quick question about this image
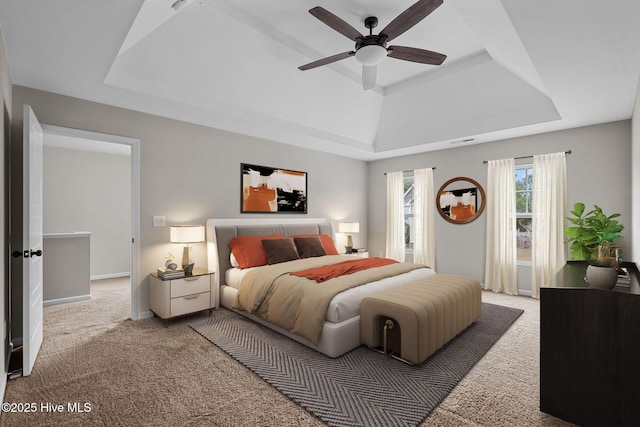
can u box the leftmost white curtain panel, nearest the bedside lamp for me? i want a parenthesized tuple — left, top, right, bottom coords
(386, 172, 404, 262)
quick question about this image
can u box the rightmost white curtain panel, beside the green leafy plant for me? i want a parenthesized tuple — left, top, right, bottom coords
(531, 153, 567, 298)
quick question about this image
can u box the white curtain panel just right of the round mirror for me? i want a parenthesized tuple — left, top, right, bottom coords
(484, 159, 518, 295)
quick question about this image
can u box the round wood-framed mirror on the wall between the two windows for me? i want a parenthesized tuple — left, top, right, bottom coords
(436, 176, 485, 224)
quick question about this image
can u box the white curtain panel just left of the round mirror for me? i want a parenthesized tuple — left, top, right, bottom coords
(413, 168, 436, 268)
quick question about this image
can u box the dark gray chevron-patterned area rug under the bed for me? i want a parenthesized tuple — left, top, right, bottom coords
(190, 303, 522, 427)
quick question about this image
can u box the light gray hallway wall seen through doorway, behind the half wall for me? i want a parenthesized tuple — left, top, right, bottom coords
(43, 146, 131, 279)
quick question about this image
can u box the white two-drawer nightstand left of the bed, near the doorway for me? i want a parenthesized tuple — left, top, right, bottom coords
(149, 268, 218, 326)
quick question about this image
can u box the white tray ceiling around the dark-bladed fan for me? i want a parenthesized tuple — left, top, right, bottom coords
(0, 0, 640, 160)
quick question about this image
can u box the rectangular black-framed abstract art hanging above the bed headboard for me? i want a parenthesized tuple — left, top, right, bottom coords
(240, 163, 307, 214)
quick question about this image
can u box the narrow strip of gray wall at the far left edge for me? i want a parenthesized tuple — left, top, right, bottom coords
(0, 31, 12, 400)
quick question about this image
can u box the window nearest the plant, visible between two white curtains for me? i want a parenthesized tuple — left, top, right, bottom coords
(516, 165, 533, 262)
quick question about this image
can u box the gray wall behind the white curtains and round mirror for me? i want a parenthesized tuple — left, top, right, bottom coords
(368, 120, 633, 291)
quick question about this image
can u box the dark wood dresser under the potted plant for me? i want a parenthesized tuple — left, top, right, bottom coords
(540, 261, 640, 426)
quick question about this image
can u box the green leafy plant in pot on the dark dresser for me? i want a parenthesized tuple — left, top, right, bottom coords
(564, 202, 624, 266)
